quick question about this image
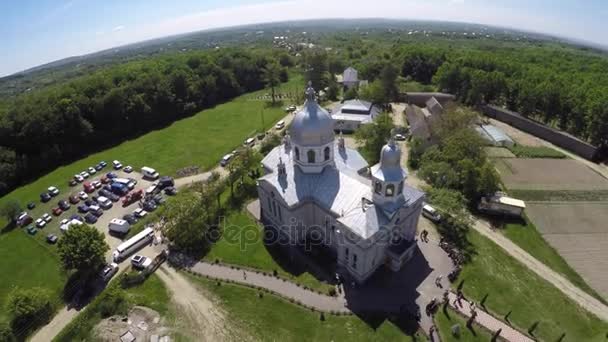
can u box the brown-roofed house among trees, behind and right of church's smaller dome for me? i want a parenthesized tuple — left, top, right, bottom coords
(405, 97, 444, 146)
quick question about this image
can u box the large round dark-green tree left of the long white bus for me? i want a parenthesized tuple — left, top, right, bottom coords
(57, 224, 110, 273)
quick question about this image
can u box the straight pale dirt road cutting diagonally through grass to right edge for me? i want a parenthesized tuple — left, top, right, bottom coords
(473, 220, 608, 322)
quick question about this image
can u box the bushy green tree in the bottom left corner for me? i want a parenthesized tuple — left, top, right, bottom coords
(7, 287, 54, 331)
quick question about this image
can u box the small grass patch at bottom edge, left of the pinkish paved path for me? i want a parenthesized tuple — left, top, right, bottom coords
(435, 308, 492, 342)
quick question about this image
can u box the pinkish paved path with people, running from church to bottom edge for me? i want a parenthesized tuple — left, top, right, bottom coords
(440, 292, 534, 342)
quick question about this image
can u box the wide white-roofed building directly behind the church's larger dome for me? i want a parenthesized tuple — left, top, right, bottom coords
(331, 100, 380, 132)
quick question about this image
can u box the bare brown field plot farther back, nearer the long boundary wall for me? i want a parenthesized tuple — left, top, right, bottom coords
(495, 158, 608, 190)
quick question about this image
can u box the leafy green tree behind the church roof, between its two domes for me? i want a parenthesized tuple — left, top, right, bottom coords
(355, 113, 395, 164)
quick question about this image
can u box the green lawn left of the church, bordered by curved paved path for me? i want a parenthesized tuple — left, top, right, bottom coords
(205, 209, 333, 293)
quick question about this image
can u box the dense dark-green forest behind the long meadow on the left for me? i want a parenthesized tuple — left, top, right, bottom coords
(0, 49, 291, 195)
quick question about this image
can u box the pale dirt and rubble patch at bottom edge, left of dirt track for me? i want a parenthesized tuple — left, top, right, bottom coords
(94, 306, 170, 341)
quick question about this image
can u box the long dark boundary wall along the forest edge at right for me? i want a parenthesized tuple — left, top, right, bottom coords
(481, 105, 599, 160)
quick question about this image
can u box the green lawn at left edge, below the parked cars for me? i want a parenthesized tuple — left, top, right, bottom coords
(0, 229, 67, 320)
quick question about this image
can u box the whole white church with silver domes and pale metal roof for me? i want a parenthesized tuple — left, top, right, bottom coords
(258, 87, 424, 283)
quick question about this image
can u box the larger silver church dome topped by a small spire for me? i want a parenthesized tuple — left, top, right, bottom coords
(290, 86, 334, 146)
